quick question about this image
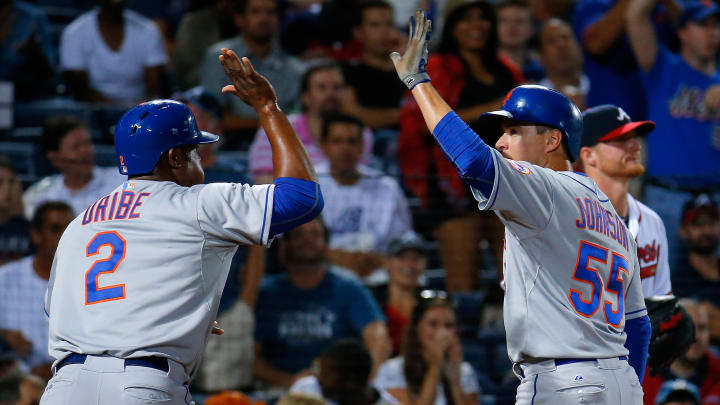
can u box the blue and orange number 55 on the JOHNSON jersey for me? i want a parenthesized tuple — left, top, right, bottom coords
(568, 241, 630, 327)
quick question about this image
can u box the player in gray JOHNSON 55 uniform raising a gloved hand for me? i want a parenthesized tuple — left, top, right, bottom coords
(391, 11, 650, 404)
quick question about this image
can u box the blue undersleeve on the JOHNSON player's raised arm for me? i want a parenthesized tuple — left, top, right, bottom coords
(433, 111, 495, 196)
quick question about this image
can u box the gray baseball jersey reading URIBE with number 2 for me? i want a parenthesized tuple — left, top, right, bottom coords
(45, 180, 274, 375)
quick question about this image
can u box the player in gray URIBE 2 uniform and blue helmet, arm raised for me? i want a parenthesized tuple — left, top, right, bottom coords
(41, 49, 323, 405)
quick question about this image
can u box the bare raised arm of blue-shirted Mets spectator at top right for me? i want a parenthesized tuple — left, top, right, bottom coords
(625, 0, 658, 72)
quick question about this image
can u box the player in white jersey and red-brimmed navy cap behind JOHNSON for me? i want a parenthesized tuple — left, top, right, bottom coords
(578, 104, 672, 297)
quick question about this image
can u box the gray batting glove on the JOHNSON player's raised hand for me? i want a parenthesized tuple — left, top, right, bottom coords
(390, 10, 432, 90)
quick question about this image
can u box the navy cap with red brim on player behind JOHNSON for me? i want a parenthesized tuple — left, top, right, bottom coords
(581, 104, 655, 146)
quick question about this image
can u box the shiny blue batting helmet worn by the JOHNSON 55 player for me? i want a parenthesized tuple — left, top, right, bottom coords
(479, 85, 583, 161)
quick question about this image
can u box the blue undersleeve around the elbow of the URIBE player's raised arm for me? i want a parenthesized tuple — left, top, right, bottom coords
(270, 177, 325, 238)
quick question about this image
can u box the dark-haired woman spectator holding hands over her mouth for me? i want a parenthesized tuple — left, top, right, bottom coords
(374, 290, 480, 405)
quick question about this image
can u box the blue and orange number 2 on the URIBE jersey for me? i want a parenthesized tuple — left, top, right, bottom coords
(85, 231, 127, 305)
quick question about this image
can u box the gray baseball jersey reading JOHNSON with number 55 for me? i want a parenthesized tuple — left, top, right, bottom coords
(473, 150, 647, 362)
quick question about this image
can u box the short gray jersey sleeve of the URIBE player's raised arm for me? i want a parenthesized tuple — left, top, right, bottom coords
(197, 183, 275, 245)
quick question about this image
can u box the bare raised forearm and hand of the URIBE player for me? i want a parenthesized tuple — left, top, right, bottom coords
(219, 48, 317, 182)
